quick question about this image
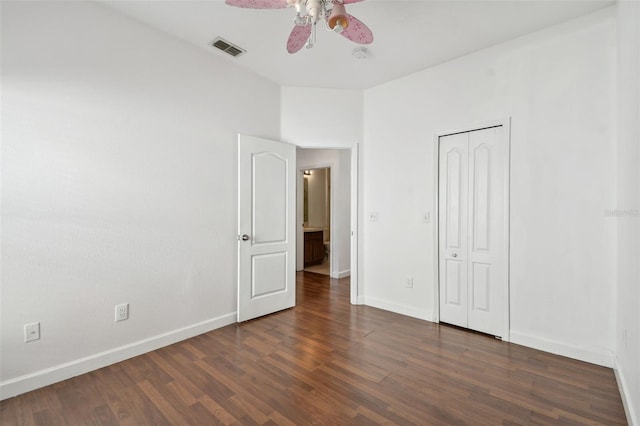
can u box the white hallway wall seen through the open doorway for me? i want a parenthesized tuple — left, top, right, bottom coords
(297, 148, 351, 278)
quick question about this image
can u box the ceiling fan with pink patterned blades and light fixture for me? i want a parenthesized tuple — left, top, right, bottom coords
(225, 0, 373, 53)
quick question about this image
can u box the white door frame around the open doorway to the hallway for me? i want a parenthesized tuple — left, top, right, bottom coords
(296, 142, 364, 305)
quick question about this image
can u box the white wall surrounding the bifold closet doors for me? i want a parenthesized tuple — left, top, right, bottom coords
(363, 8, 616, 365)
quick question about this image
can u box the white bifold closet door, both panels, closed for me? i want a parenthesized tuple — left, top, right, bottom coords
(438, 127, 507, 336)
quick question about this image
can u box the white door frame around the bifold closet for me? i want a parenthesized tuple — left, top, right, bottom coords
(433, 117, 511, 342)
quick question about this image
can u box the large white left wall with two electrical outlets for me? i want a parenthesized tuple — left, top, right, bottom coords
(0, 2, 280, 398)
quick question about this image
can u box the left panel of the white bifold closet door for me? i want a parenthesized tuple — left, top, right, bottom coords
(438, 133, 469, 327)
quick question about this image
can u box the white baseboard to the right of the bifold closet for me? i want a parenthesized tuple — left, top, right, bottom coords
(509, 330, 614, 368)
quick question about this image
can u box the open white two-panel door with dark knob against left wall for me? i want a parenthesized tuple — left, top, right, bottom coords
(238, 135, 296, 322)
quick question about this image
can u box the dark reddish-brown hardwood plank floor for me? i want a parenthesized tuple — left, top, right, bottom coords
(0, 273, 626, 426)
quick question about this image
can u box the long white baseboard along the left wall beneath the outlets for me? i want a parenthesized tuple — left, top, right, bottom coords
(0, 312, 237, 400)
